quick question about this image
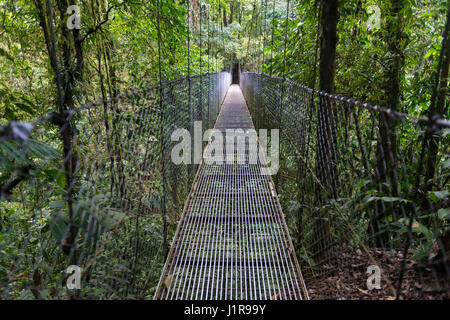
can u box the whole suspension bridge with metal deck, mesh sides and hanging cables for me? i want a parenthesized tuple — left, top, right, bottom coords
(0, 1, 450, 300)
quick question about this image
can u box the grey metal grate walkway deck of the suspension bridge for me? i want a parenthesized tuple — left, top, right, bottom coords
(155, 85, 308, 300)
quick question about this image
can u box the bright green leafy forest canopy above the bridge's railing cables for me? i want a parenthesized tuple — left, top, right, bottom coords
(0, 0, 447, 122)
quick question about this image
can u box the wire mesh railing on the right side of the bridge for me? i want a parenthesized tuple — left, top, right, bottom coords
(240, 72, 450, 298)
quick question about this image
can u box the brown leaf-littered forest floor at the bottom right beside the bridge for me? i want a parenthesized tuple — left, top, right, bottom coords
(306, 246, 450, 300)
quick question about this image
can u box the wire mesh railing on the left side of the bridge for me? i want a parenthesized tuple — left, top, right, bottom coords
(0, 72, 231, 299)
